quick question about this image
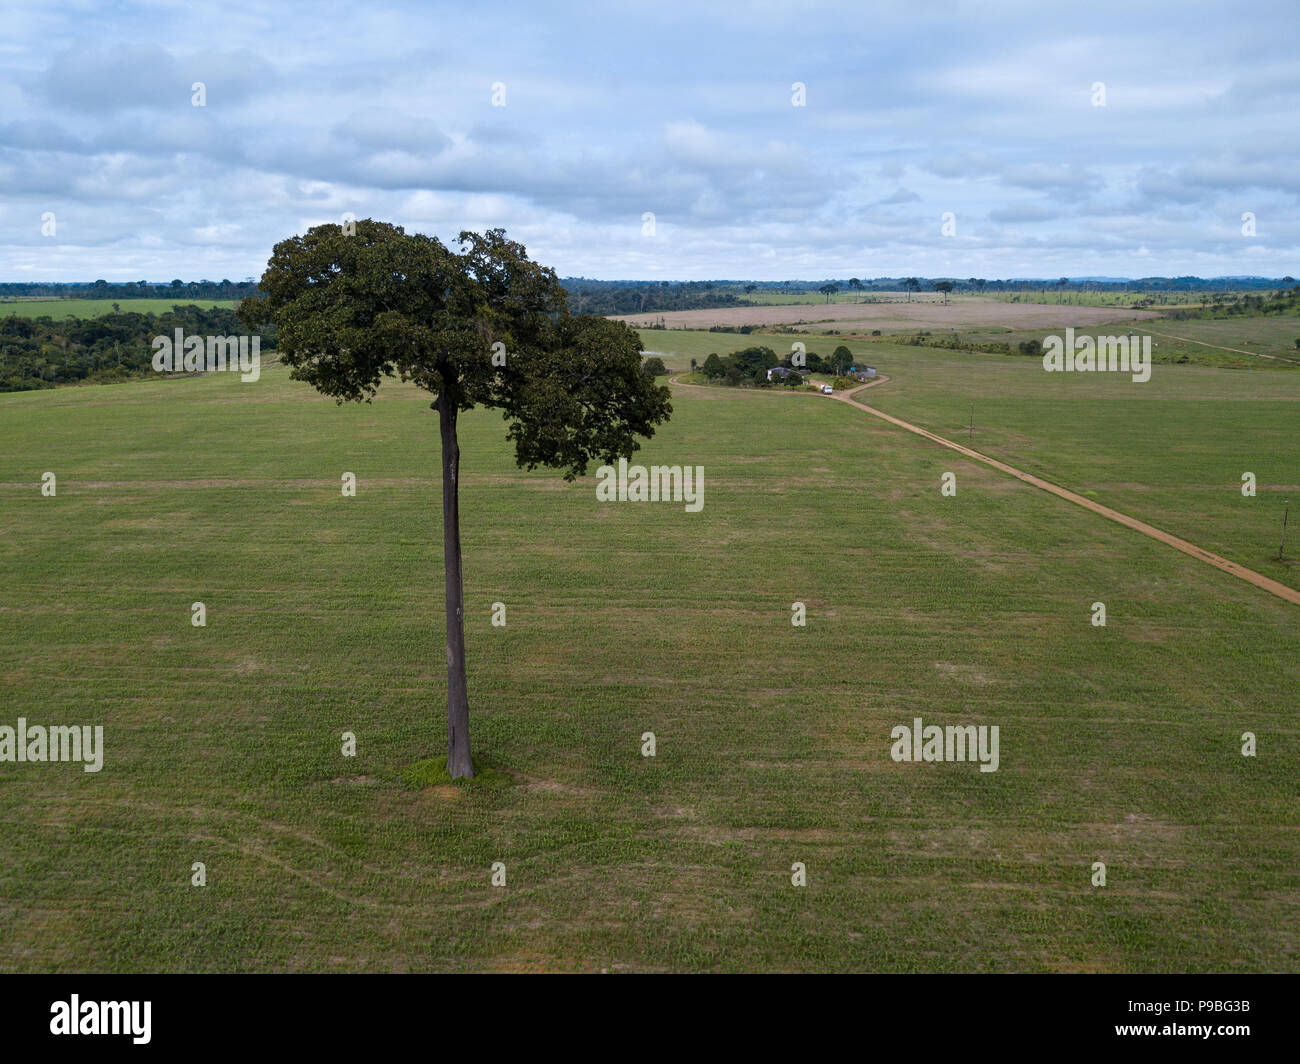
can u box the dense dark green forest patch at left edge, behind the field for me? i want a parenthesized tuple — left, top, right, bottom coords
(0, 306, 276, 392)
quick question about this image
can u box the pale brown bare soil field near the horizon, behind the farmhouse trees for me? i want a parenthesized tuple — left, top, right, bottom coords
(618, 298, 1160, 329)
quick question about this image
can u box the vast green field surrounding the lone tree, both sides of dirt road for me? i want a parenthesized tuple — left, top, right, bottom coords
(0, 332, 1300, 972)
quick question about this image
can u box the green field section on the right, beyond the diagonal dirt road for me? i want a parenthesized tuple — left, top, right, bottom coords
(865, 346, 1300, 588)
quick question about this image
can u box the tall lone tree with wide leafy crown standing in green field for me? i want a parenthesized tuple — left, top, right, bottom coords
(239, 219, 672, 779)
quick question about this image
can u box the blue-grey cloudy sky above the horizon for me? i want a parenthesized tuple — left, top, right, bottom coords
(0, 0, 1300, 281)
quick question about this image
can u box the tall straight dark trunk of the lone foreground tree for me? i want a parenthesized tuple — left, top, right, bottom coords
(434, 389, 475, 779)
